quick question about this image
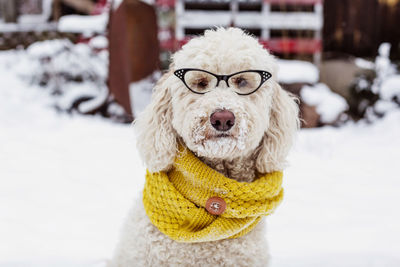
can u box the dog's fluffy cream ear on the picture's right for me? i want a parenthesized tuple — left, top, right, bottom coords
(256, 81, 300, 173)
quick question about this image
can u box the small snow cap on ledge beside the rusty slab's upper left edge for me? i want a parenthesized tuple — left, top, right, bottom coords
(58, 12, 108, 35)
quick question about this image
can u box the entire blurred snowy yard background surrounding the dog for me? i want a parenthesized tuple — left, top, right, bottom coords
(0, 0, 400, 267)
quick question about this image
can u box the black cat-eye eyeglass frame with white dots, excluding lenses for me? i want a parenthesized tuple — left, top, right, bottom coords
(174, 68, 272, 95)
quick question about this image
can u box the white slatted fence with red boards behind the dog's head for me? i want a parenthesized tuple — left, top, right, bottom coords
(175, 0, 323, 61)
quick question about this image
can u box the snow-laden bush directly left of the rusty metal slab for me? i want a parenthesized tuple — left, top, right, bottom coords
(7, 39, 108, 113)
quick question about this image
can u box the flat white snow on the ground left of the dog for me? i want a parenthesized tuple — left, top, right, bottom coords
(0, 55, 144, 266)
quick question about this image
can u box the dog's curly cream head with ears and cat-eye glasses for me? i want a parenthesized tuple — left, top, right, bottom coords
(135, 28, 299, 173)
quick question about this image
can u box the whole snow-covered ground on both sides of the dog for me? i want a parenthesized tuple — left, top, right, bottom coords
(0, 50, 400, 267)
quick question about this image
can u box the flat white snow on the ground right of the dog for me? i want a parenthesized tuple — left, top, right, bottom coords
(268, 113, 400, 267)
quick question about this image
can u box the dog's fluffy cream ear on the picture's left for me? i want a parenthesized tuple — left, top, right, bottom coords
(134, 67, 177, 172)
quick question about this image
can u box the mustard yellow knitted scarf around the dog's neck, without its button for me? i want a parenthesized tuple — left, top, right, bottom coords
(143, 149, 283, 243)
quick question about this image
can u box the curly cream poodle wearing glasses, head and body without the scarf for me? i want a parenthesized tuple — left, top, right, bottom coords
(111, 28, 299, 267)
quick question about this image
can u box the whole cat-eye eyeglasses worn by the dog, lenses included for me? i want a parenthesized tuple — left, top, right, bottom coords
(174, 69, 272, 95)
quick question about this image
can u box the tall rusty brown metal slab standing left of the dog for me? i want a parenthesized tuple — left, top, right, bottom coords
(109, 0, 159, 114)
